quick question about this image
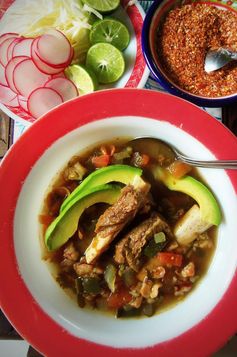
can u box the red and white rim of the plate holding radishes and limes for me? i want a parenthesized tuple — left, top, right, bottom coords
(0, 0, 149, 125)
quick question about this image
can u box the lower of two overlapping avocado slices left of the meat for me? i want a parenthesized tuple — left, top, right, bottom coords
(45, 185, 121, 251)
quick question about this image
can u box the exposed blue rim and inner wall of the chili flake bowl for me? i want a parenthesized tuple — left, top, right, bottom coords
(142, 0, 237, 107)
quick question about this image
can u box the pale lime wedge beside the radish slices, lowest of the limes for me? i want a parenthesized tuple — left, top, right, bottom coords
(65, 64, 98, 95)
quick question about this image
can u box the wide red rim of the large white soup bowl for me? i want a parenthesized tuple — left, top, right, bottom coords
(0, 89, 237, 357)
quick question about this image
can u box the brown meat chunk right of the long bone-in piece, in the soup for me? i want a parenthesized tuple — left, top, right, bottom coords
(114, 212, 173, 271)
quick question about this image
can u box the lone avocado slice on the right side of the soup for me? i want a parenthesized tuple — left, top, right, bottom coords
(153, 167, 221, 226)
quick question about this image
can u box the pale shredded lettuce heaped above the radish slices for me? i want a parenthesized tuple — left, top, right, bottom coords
(0, 0, 99, 62)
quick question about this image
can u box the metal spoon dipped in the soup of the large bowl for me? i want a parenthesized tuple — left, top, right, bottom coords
(129, 137, 237, 170)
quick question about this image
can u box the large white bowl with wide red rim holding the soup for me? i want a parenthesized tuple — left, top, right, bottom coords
(0, 89, 237, 357)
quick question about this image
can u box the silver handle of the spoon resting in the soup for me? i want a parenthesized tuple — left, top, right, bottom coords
(175, 154, 237, 170)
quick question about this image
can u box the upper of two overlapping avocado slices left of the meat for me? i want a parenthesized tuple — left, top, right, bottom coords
(60, 165, 142, 212)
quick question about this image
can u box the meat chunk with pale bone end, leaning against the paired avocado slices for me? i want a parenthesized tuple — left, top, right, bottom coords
(85, 176, 150, 263)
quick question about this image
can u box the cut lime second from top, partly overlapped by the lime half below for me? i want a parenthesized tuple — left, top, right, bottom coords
(90, 18, 130, 51)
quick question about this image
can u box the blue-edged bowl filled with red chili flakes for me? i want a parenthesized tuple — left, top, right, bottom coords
(142, 0, 237, 107)
